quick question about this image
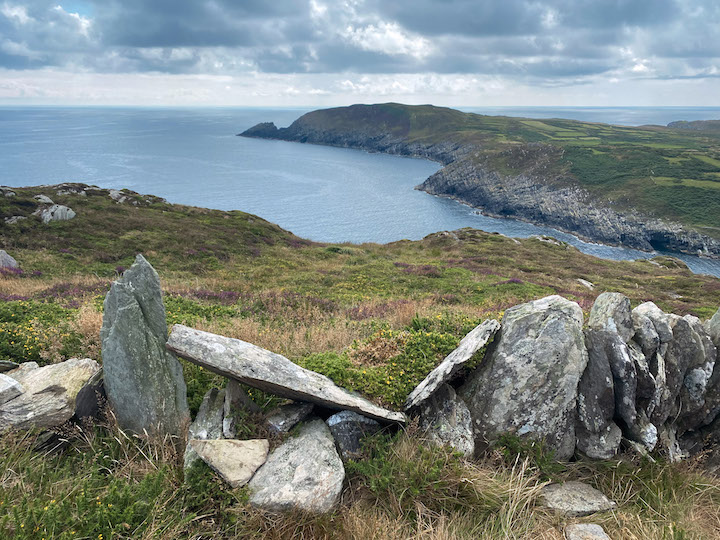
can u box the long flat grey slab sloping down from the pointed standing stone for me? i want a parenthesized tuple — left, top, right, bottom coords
(167, 324, 406, 423)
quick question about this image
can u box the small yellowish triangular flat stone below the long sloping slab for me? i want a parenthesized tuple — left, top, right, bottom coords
(189, 439, 270, 488)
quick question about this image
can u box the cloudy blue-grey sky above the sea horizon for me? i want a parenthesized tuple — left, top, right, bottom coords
(0, 0, 720, 107)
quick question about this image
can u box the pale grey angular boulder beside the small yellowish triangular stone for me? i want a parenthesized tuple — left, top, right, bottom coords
(248, 419, 345, 513)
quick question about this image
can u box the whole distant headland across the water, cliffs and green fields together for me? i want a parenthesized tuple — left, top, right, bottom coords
(240, 103, 720, 258)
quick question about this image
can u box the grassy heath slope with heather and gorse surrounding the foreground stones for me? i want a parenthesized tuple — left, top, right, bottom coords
(0, 188, 720, 538)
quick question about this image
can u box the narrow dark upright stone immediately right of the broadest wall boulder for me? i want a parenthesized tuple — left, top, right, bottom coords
(575, 329, 622, 459)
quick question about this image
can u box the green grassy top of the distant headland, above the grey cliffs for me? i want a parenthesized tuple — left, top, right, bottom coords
(296, 103, 720, 236)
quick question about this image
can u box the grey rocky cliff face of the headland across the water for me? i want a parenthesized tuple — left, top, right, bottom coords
(240, 104, 720, 258)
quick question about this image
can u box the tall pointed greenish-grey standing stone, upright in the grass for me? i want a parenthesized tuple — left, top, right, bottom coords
(100, 255, 190, 437)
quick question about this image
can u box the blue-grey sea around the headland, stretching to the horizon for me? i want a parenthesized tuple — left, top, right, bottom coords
(0, 107, 720, 277)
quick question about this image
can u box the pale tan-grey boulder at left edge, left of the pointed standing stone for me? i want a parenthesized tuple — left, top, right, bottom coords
(0, 358, 100, 431)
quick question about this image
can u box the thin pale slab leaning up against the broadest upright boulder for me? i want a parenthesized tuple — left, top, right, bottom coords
(405, 319, 500, 411)
